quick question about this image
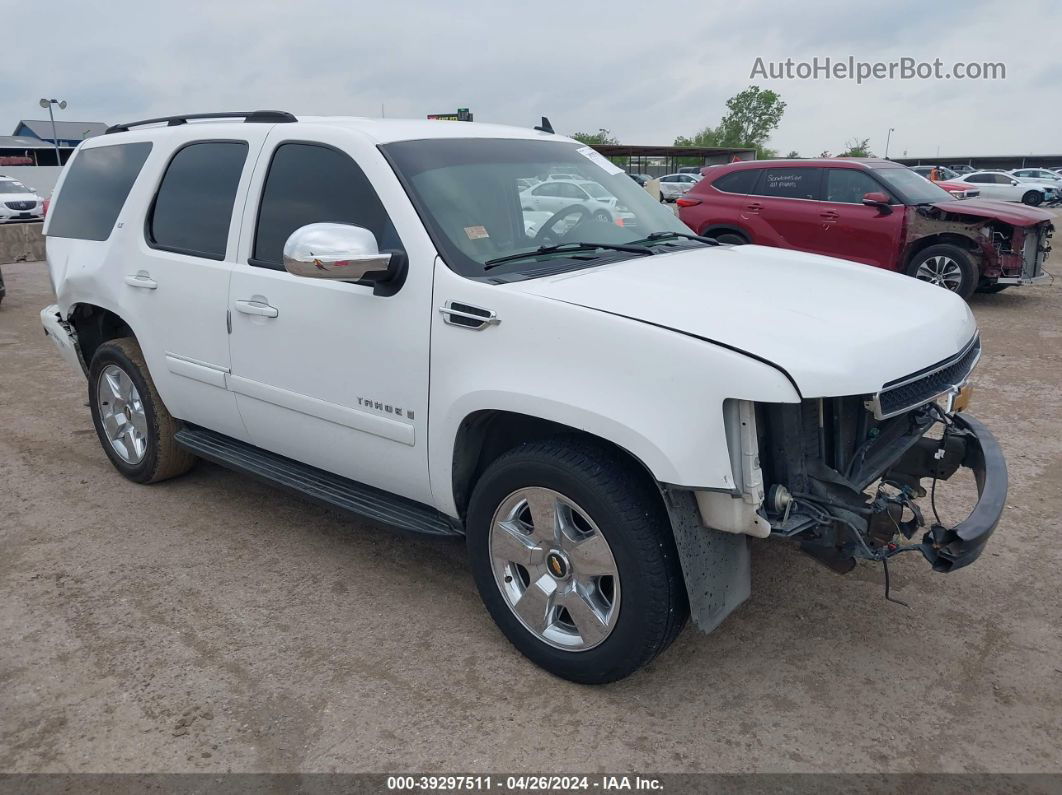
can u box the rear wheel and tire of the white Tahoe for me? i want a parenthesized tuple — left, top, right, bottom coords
(88, 338, 195, 483)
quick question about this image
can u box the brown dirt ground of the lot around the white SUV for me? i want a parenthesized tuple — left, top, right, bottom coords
(0, 232, 1062, 773)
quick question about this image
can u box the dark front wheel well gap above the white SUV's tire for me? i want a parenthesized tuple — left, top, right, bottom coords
(452, 410, 656, 519)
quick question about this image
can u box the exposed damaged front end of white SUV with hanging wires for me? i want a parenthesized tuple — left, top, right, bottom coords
(756, 339, 1007, 572)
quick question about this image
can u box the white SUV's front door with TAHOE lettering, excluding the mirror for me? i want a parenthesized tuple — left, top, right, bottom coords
(228, 125, 433, 502)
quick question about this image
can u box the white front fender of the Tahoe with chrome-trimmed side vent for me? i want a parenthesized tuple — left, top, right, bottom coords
(428, 266, 800, 515)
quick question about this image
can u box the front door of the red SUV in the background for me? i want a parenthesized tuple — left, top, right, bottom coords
(818, 168, 906, 269)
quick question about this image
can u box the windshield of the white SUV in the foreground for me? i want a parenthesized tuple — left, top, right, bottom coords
(380, 138, 689, 277)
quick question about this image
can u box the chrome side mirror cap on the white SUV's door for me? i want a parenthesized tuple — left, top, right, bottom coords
(284, 224, 391, 281)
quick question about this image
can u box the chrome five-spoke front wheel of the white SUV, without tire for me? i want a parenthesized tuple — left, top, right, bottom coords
(490, 487, 619, 652)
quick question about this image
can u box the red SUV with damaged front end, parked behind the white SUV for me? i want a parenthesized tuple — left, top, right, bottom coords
(678, 159, 1055, 298)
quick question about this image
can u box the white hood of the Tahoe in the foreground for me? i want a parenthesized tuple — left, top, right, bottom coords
(508, 245, 977, 397)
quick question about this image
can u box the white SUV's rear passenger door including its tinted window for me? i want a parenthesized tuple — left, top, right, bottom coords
(123, 131, 268, 438)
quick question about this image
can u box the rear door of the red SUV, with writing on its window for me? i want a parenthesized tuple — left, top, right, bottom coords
(741, 167, 826, 253)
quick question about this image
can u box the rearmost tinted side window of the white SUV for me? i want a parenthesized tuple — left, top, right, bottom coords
(48, 141, 151, 240)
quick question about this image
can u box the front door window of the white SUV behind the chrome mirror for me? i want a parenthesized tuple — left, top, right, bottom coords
(251, 143, 401, 270)
